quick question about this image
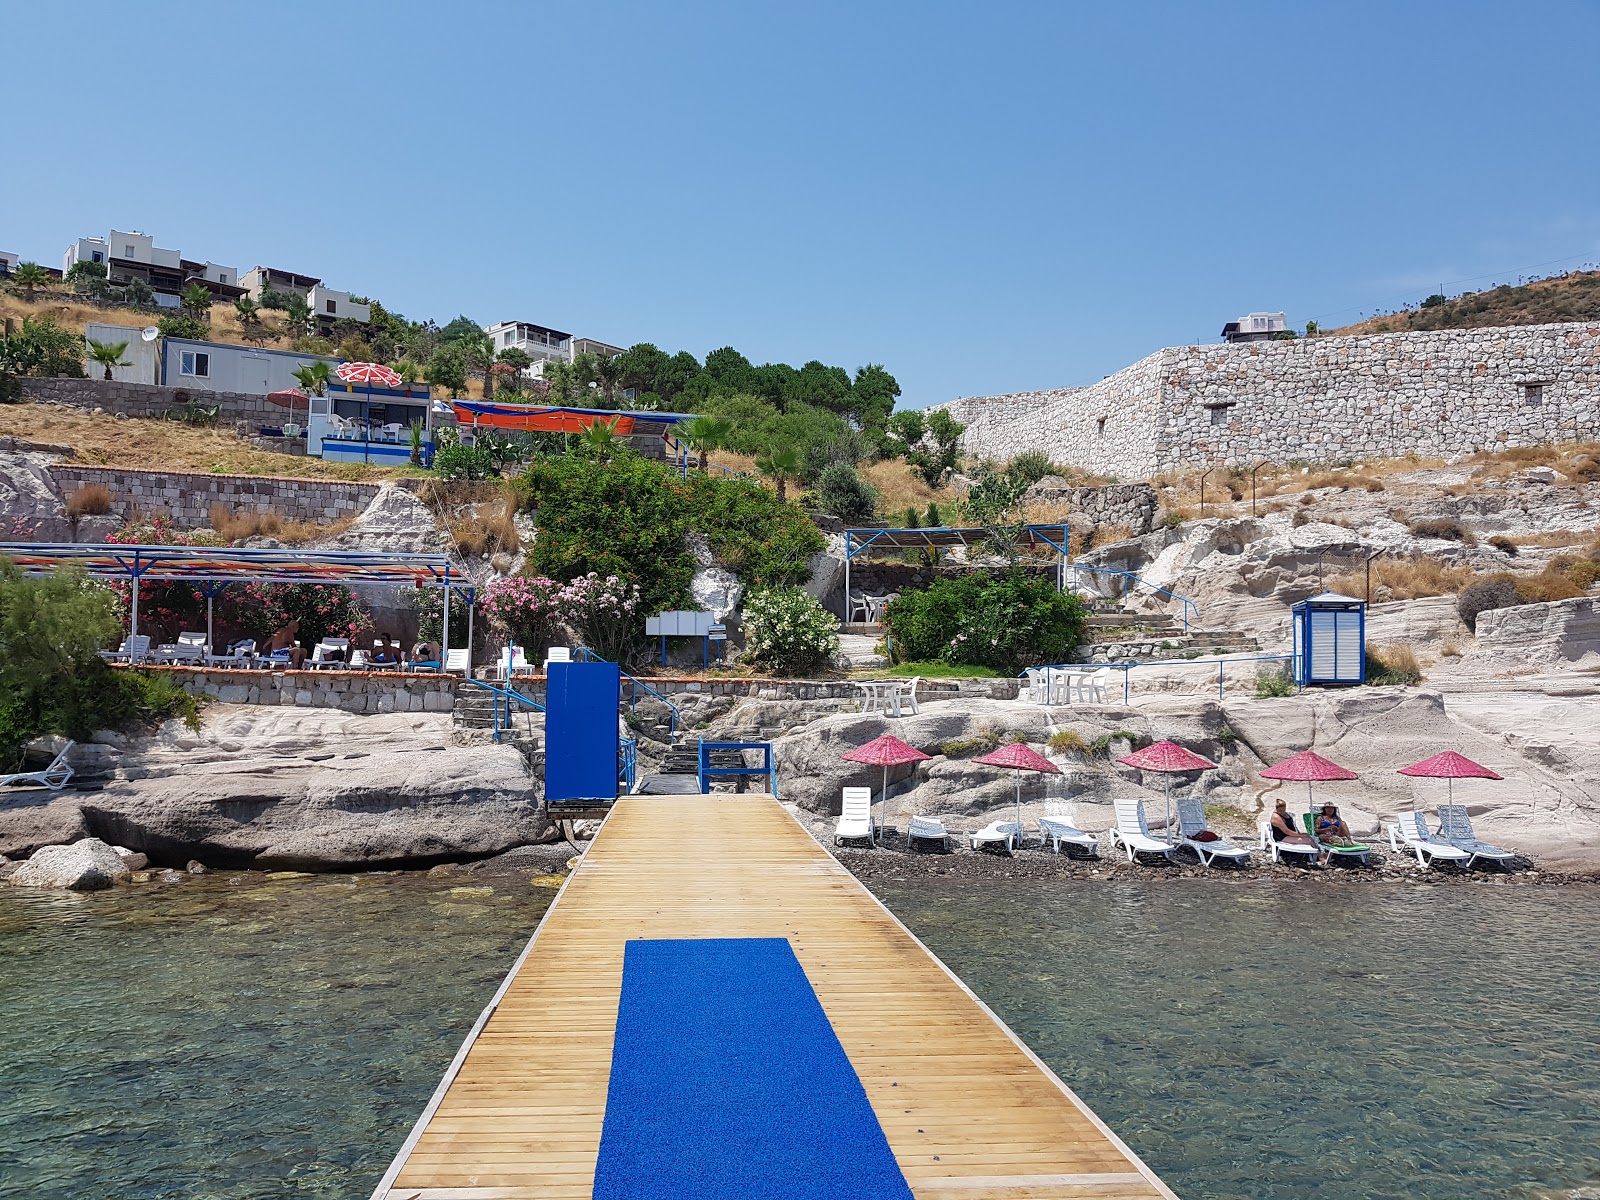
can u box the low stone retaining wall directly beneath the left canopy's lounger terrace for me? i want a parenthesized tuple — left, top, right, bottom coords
(147, 667, 461, 712)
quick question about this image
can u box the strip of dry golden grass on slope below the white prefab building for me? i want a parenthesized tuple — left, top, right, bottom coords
(0, 405, 421, 482)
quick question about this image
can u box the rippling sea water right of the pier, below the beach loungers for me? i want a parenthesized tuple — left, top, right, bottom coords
(874, 880, 1600, 1200)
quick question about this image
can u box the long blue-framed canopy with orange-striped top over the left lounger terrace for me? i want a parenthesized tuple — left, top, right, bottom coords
(0, 542, 474, 669)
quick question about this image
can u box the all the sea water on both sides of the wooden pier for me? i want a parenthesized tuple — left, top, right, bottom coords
(0, 875, 1600, 1200)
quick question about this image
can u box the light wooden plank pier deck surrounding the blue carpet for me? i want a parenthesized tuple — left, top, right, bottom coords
(373, 795, 1176, 1200)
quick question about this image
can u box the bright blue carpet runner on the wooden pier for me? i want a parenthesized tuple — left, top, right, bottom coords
(594, 938, 912, 1200)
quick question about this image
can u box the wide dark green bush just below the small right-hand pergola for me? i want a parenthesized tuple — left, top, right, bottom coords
(885, 571, 1088, 674)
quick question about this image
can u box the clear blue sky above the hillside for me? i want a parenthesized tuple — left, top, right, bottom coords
(0, 0, 1600, 405)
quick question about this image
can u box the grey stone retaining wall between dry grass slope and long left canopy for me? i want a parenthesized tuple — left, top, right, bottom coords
(50, 467, 379, 530)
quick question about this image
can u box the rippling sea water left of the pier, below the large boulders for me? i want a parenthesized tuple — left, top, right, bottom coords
(0, 874, 550, 1200)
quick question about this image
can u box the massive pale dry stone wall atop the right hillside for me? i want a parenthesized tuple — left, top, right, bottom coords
(944, 323, 1600, 478)
